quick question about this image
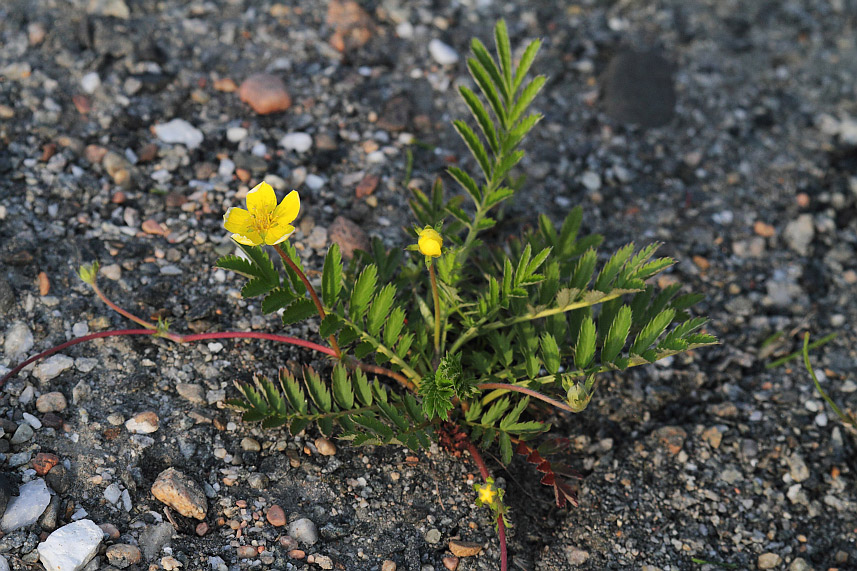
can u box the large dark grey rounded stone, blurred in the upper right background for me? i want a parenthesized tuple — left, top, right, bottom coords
(602, 50, 676, 128)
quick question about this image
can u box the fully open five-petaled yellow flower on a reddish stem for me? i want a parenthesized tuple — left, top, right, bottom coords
(223, 182, 301, 246)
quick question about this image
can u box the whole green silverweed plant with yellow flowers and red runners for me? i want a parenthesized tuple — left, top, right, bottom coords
(4, 21, 716, 570)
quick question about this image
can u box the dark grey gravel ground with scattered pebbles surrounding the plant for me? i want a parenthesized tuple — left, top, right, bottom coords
(0, 0, 857, 571)
